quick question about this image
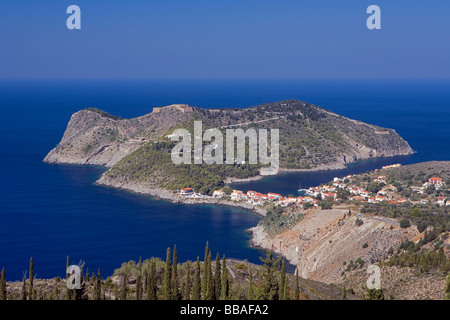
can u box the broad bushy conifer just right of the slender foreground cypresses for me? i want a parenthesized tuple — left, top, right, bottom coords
(260, 251, 281, 300)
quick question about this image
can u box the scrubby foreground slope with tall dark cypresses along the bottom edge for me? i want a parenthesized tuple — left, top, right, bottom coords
(0, 243, 339, 300)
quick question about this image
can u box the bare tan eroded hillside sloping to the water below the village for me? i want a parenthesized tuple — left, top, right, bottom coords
(249, 209, 419, 283)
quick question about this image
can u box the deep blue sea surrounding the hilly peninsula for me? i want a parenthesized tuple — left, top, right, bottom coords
(0, 80, 450, 280)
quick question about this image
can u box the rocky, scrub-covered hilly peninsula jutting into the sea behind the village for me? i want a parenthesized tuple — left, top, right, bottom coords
(45, 100, 413, 193)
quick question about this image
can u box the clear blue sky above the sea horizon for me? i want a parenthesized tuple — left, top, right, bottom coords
(0, 0, 450, 79)
